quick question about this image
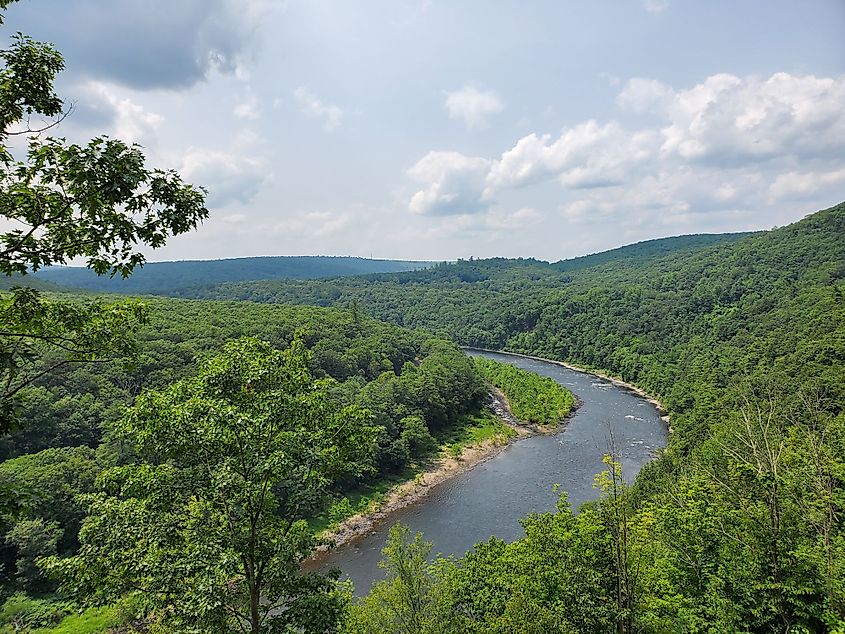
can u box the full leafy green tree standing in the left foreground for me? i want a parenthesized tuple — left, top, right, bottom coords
(45, 337, 376, 633)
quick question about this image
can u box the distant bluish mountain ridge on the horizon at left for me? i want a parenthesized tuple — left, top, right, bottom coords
(34, 256, 431, 295)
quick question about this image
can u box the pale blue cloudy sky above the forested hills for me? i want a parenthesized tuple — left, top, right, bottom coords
(2, 0, 845, 261)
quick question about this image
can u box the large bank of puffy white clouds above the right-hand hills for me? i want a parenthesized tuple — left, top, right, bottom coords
(408, 73, 845, 227)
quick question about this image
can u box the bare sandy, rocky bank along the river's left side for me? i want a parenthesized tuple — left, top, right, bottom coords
(314, 387, 580, 558)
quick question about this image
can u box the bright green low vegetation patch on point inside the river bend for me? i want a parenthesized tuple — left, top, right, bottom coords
(473, 357, 575, 425)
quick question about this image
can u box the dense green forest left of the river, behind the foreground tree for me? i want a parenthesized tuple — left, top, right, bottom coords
(0, 300, 486, 596)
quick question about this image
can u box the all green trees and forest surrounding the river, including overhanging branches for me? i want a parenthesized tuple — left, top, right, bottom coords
(0, 0, 845, 634)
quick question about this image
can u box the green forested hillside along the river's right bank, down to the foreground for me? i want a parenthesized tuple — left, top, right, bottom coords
(186, 205, 845, 632)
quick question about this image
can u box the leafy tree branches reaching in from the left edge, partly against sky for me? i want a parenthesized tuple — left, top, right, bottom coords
(0, 0, 208, 433)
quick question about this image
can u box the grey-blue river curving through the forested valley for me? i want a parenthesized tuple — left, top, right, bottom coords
(310, 351, 668, 595)
